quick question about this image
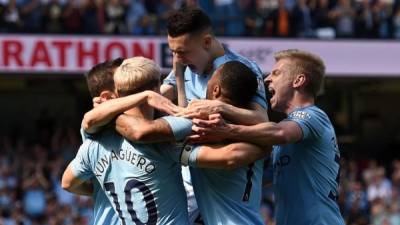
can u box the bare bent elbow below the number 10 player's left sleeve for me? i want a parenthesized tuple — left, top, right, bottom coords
(61, 164, 93, 196)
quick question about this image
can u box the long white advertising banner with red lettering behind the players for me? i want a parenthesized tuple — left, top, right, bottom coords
(0, 35, 400, 77)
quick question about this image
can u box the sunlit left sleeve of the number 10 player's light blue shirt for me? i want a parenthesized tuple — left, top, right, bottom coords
(71, 140, 95, 180)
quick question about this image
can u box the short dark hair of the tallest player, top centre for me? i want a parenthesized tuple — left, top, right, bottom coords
(167, 7, 212, 37)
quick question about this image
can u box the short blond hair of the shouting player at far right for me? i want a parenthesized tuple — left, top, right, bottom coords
(274, 49, 325, 97)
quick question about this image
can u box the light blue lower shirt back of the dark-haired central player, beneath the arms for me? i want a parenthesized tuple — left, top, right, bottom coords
(190, 157, 263, 225)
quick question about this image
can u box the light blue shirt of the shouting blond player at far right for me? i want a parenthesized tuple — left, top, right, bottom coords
(272, 106, 344, 225)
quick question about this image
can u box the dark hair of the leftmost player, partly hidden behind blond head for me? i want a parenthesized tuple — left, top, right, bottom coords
(85, 58, 124, 97)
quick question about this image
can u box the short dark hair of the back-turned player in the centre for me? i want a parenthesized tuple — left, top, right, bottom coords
(218, 61, 258, 108)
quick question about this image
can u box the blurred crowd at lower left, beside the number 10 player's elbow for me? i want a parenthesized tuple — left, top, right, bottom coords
(0, 127, 93, 225)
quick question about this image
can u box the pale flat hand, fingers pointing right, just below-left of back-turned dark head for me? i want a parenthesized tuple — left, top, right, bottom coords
(175, 100, 223, 120)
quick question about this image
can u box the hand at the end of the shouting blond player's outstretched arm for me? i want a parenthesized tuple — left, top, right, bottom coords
(189, 114, 230, 143)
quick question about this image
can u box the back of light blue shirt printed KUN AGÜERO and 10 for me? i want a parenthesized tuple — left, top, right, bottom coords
(90, 132, 188, 225)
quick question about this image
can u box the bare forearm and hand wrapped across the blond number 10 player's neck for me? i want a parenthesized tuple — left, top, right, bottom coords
(82, 91, 177, 133)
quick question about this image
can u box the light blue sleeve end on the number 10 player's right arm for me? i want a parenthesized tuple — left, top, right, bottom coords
(162, 116, 192, 141)
